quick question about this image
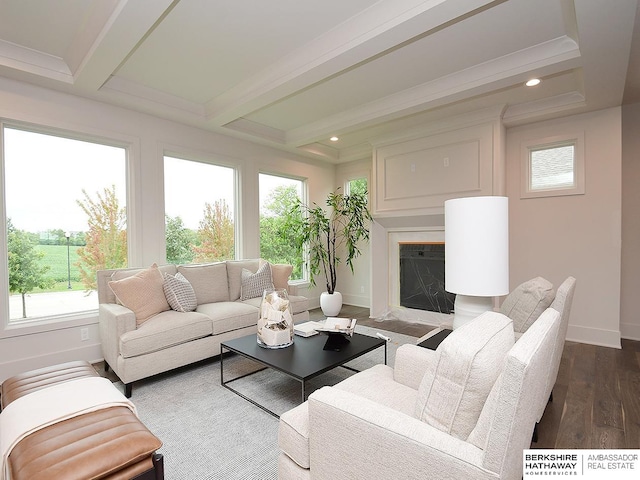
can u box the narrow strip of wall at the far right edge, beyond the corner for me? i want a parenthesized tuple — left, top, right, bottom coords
(620, 103, 640, 340)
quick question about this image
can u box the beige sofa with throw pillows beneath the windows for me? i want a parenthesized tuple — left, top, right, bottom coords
(97, 259, 309, 397)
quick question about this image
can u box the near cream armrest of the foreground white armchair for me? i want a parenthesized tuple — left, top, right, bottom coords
(309, 387, 498, 479)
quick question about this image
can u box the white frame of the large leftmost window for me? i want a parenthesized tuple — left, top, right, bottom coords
(0, 117, 135, 339)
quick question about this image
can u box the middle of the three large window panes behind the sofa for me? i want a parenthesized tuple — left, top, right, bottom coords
(164, 156, 235, 264)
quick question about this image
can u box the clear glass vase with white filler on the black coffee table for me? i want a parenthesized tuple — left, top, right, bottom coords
(258, 288, 293, 348)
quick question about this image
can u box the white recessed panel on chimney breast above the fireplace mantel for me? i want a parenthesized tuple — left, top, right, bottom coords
(373, 123, 494, 215)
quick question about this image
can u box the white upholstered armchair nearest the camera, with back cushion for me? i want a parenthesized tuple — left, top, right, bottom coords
(279, 309, 559, 479)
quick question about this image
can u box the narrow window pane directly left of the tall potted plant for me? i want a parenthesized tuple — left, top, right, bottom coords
(259, 173, 304, 280)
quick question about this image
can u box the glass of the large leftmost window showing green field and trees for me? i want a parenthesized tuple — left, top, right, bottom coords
(2, 126, 127, 323)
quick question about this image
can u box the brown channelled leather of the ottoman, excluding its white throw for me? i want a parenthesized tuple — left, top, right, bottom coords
(0, 362, 164, 480)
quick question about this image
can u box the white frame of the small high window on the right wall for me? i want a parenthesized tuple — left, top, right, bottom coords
(520, 132, 585, 198)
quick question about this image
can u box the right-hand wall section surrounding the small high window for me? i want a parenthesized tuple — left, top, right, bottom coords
(506, 108, 620, 348)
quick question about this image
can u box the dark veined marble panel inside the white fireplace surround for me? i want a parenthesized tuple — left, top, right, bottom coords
(399, 242, 455, 314)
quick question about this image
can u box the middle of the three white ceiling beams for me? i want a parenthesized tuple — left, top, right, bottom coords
(205, 0, 504, 126)
